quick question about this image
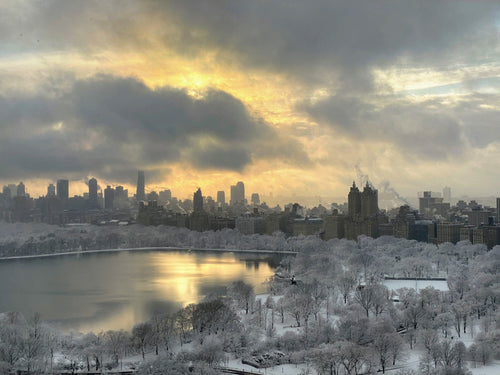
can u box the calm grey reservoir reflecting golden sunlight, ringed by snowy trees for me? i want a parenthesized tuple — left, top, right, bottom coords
(0, 250, 280, 333)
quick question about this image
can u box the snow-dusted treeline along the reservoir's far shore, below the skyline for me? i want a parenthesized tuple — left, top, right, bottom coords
(0, 223, 292, 257)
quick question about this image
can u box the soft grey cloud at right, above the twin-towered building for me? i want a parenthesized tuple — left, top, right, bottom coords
(301, 95, 500, 160)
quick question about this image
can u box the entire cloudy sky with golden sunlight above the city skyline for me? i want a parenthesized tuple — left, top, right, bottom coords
(0, 0, 500, 206)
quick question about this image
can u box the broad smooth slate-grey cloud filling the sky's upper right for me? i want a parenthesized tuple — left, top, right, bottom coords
(152, 0, 500, 89)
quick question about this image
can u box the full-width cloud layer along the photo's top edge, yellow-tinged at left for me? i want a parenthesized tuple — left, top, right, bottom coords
(0, 0, 500, 91)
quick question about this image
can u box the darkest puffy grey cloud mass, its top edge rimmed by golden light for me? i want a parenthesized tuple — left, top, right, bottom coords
(71, 76, 267, 141)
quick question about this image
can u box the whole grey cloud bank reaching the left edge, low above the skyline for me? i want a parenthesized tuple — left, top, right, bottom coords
(0, 75, 304, 182)
